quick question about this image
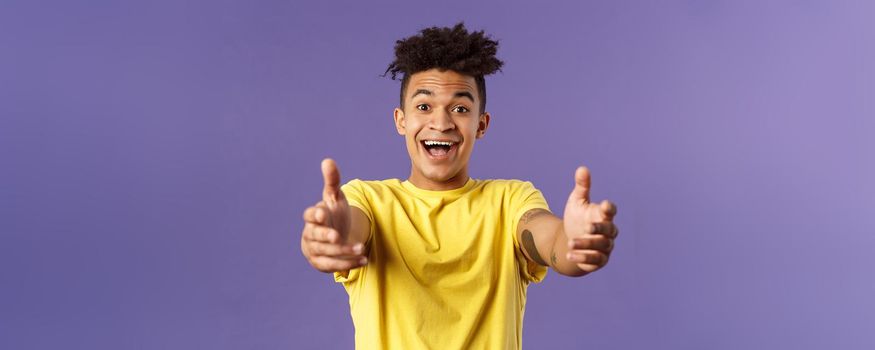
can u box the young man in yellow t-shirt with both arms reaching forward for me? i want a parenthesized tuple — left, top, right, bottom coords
(301, 23, 617, 349)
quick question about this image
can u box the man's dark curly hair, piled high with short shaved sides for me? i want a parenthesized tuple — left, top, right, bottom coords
(383, 22, 504, 113)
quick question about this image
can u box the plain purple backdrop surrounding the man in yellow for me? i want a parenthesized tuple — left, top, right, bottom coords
(0, 0, 875, 349)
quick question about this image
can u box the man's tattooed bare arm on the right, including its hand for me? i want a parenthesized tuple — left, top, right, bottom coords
(516, 167, 619, 277)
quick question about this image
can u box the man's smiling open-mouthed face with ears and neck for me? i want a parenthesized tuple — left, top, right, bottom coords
(395, 69, 489, 190)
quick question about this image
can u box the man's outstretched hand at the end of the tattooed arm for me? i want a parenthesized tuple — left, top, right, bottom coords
(563, 167, 619, 273)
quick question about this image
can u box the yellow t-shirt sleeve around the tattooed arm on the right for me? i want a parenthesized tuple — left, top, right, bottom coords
(511, 181, 550, 283)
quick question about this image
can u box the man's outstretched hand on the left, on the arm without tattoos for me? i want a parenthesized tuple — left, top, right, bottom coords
(301, 159, 367, 272)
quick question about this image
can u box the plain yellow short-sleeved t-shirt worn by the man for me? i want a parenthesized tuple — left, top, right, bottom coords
(335, 179, 549, 350)
